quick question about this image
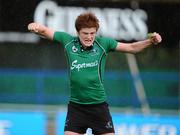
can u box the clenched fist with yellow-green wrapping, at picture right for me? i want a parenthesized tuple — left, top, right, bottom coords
(148, 32, 162, 45)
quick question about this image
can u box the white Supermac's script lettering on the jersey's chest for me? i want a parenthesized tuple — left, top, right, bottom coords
(71, 60, 98, 71)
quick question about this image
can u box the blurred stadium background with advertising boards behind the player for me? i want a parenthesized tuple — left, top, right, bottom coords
(0, 0, 180, 135)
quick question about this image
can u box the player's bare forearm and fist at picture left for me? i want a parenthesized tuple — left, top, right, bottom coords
(28, 22, 54, 40)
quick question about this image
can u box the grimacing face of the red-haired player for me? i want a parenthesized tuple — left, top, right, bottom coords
(78, 27, 96, 48)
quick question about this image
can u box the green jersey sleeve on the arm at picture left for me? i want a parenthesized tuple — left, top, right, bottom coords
(53, 31, 73, 47)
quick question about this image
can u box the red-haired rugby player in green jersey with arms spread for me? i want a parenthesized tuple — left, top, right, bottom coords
(28, 12, 161, 135)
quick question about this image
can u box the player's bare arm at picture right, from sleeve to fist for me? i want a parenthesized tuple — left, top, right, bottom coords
(116, 32, 162, 53)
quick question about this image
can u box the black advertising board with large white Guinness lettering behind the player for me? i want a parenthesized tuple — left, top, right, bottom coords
(0, 0, 180, 47)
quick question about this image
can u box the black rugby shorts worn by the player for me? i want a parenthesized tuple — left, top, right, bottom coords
(64, 102, 114, 134)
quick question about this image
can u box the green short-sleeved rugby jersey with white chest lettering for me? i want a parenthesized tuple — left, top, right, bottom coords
(53, 32, 117, 104)
